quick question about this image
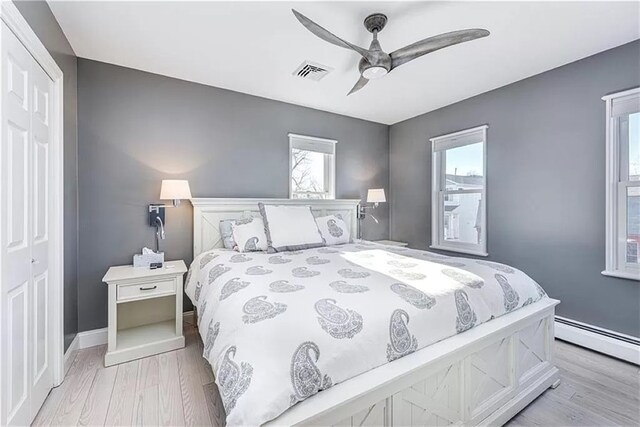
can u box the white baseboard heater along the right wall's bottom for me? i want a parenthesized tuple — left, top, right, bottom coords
(555, 316, 640, 365)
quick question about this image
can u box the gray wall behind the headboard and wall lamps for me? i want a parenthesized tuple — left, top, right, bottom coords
(78, 59, 389, 331)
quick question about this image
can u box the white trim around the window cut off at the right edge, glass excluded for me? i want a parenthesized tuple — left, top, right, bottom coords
(602, 88, 640, 281)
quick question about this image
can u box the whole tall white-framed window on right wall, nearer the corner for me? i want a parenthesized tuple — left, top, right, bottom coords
(431, 126, 487, 256)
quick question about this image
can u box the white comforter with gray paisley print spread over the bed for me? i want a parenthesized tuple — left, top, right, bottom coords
(186, 242, 546, 425)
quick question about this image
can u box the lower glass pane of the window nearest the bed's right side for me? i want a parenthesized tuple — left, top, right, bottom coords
(443, 193, 482, 244)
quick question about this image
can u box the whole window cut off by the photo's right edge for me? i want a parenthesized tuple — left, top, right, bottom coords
(602, 88, 640, 280)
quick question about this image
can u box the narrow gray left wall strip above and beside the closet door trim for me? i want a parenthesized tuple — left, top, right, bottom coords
(14, 1, 78, 350)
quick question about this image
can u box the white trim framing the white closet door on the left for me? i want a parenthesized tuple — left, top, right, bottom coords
(0, 1, 64, 387)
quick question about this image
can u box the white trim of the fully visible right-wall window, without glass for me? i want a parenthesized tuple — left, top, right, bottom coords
(429, 125, 489, 256)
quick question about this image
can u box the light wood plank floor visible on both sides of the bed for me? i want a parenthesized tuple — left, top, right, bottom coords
(34, 324, 640, 427)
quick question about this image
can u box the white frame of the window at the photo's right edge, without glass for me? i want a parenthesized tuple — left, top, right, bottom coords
(602, 88, 640, 281)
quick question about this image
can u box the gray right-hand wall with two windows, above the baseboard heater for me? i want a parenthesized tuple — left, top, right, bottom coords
(389, 41, 640, 336)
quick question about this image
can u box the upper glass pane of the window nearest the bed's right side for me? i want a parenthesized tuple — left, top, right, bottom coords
(445, 142, 484, 190)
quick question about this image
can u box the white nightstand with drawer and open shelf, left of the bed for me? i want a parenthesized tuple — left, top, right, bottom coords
(102, 261, 187, 366)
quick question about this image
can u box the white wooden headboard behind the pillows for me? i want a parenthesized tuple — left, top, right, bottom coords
(191, 198, 360, 258)
